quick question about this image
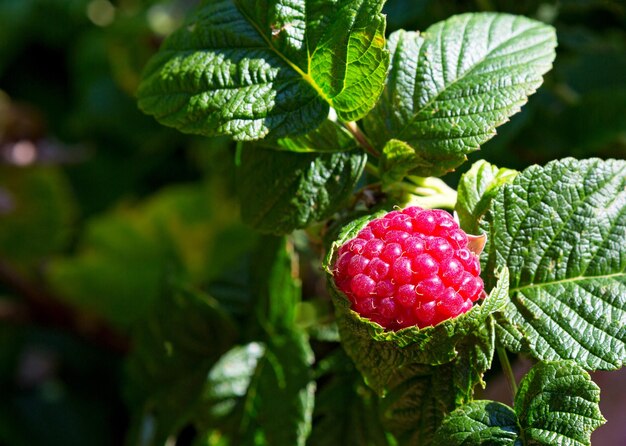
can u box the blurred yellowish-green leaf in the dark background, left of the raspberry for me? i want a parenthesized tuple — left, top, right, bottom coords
(46, 183, 255, 327)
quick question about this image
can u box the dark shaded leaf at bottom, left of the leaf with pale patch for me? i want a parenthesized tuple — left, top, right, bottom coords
(126, 289, 236, 444)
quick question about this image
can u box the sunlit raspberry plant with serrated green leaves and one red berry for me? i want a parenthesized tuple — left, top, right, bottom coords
(133, 0, 626, 445)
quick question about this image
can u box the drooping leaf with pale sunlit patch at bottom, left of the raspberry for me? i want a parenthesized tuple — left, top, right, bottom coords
(193, 331, 315, 446)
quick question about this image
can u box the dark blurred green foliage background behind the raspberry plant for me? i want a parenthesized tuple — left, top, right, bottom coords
(0, 0, 626, 446)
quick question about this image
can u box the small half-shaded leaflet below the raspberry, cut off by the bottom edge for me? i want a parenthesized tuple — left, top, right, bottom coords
(434, 401, 524, 446)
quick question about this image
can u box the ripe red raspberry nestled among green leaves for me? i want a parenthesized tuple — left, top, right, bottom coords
(333, 207, 484, 330)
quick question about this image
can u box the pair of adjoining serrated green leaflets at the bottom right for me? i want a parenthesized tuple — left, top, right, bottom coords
(435, 361, 605, 446)
